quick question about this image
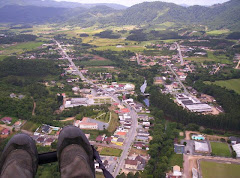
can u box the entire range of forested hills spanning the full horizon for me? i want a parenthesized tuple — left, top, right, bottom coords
(0, 0, 240, 31)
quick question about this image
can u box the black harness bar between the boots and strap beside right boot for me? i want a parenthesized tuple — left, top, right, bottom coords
(38, 145, 113, 178)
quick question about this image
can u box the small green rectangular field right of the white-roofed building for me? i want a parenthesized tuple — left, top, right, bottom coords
(210, 142, 231, 157)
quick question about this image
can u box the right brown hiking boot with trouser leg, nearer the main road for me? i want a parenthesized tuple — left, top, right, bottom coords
(57, 126, 95, 178)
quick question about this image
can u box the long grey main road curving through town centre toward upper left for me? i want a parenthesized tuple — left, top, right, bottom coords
(55, 40, 138, 177)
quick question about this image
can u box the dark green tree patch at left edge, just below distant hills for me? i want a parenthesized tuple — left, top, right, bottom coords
(0, 34, 37, 44)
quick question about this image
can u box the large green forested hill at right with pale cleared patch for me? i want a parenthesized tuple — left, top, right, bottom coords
(117, 0, 240, 29)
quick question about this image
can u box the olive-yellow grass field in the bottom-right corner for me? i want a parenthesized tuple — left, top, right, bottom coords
(200, 161, 240, 178)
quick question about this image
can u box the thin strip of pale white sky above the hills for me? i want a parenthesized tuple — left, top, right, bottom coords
(57, 0, 228, 6)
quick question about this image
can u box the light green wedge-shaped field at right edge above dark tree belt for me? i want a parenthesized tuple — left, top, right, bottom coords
(205, 79, 240, 94)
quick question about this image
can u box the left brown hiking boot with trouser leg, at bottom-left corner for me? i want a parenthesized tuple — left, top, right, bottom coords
(0, 134, 38, 178)
